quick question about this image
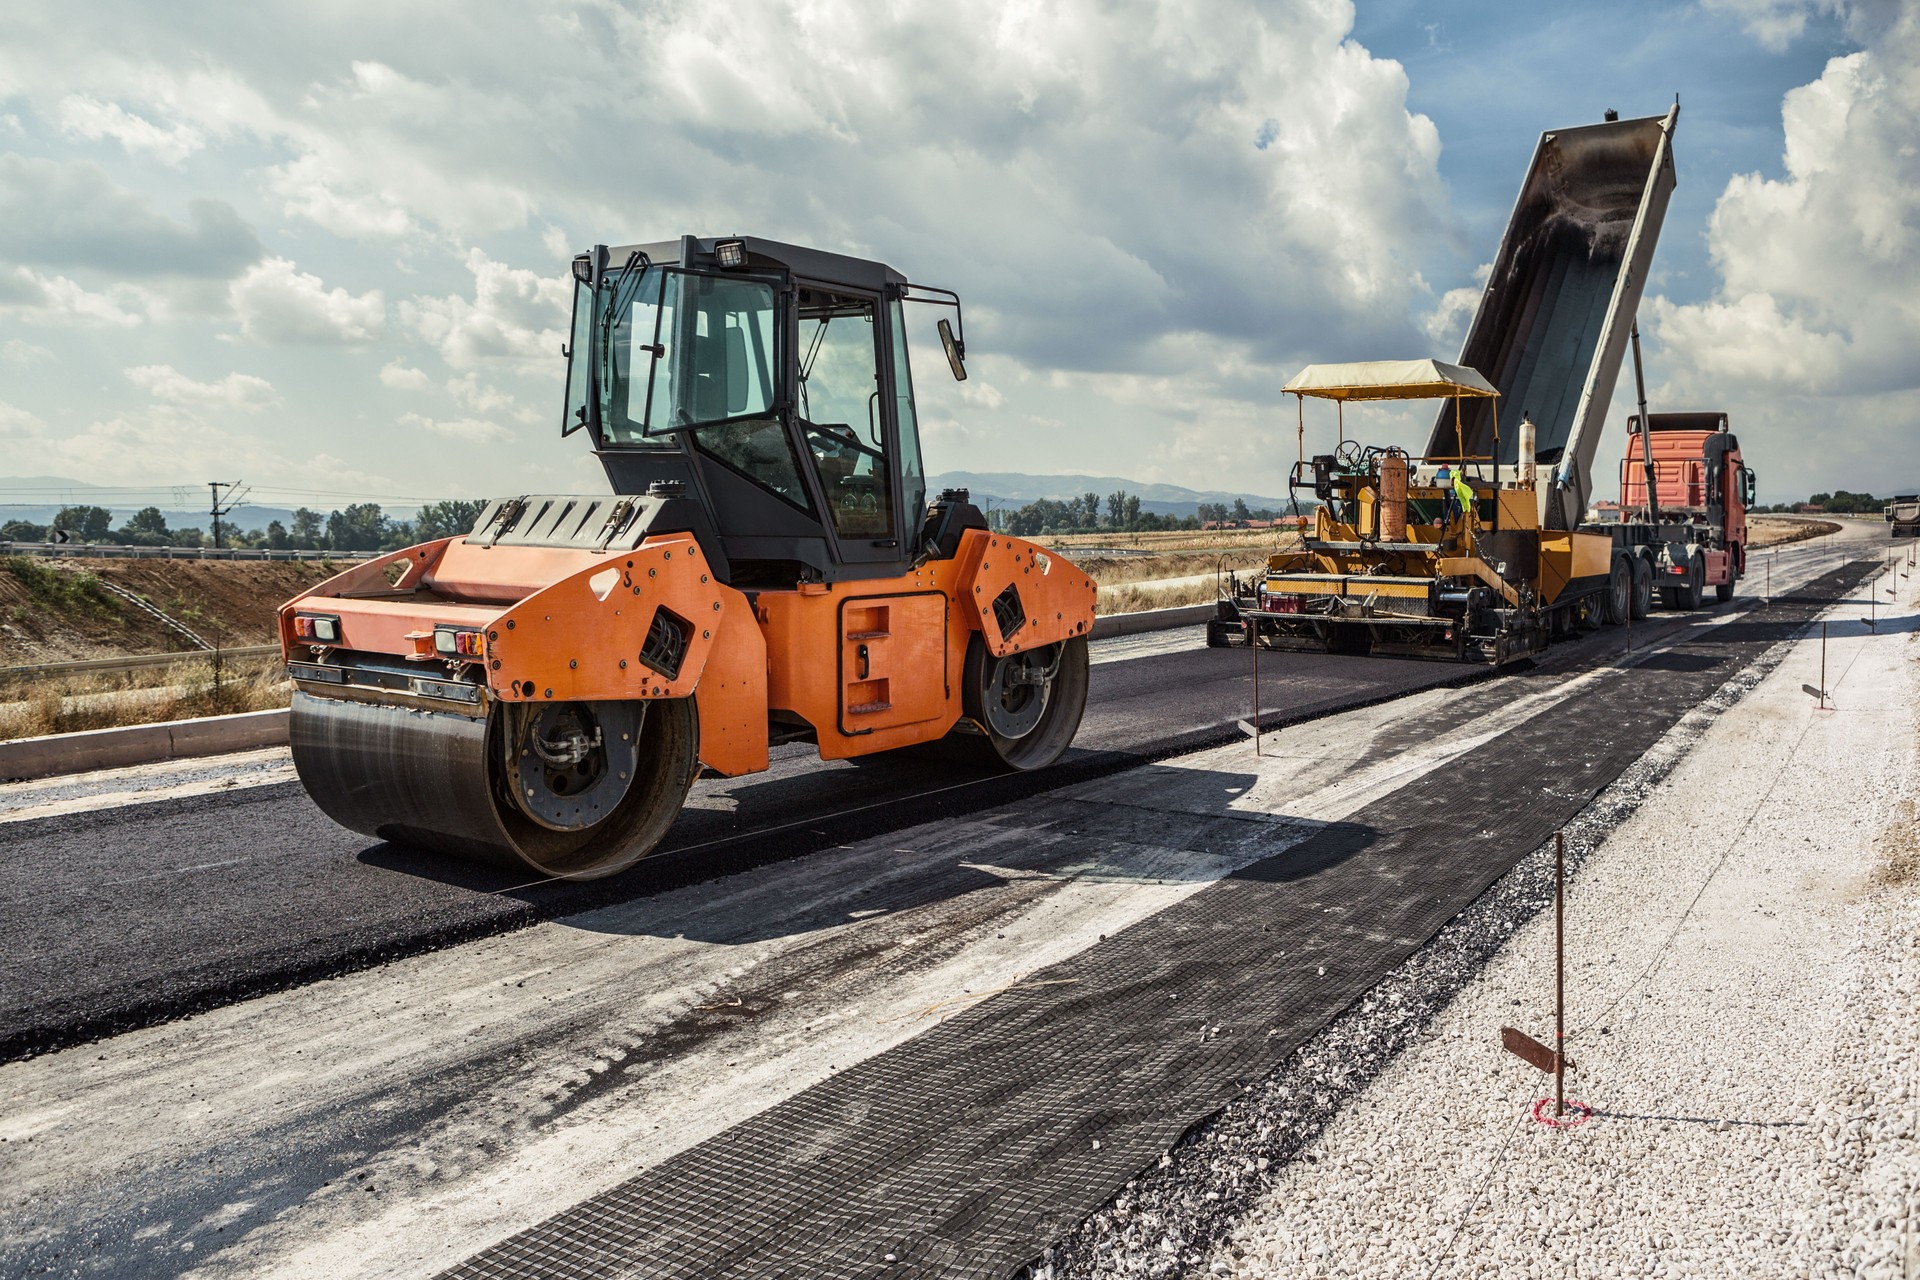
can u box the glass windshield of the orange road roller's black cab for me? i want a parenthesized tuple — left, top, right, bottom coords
(566, 263, 780, 447)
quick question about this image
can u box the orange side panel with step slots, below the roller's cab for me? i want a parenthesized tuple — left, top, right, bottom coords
(839, 591, 948, 737)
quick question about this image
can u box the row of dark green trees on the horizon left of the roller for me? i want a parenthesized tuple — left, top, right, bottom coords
(0, 497, 486, 551)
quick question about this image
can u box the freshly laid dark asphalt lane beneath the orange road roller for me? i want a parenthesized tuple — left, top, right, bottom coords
(0, 628, 1488, 1061)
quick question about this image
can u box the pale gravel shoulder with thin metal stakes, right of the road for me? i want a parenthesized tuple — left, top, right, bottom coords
(1144, 556, 1920, 1276)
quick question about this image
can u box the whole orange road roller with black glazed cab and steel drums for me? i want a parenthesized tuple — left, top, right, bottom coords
(278, 236, 1094, 879)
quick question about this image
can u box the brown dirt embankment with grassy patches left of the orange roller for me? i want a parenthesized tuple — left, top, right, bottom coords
(0, 557, 342, 666)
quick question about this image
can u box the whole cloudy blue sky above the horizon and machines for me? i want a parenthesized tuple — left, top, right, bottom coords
(0, 0, 1920, 507)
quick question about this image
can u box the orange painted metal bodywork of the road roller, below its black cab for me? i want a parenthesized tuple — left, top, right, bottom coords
(280, 530, 1094, 777)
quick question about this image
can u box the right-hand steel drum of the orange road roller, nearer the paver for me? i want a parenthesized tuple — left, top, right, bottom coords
(964, 635, 1087, 771)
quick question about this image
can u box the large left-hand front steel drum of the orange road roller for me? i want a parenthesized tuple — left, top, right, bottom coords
(288, 693, 699, 881)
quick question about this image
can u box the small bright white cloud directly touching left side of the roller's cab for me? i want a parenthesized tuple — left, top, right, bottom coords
(401, 249, 572, 368)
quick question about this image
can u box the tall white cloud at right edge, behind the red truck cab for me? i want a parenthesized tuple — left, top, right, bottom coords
(1649, 6, 1920, 495)
